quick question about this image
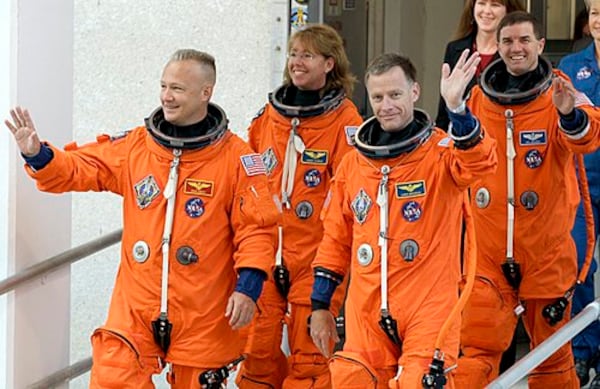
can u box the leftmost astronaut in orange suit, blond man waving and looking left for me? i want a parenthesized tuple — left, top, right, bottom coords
(5, 49, 279, 389)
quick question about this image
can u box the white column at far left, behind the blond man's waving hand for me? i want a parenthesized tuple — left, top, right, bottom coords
(0, 0, 73, 388)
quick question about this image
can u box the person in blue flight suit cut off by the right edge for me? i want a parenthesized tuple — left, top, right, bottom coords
(558, 0, 600, 389)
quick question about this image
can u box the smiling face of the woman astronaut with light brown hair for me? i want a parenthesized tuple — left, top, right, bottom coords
(287, 41, 334, 91)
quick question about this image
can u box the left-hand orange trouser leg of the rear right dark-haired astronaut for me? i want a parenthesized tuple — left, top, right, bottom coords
(454, 277, 517, 389)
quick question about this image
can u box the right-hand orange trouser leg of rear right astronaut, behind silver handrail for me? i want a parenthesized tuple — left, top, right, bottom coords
(523, 298, 579, 389)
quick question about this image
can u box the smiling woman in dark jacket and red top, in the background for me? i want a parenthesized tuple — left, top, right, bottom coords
(435, 0, 525, 130)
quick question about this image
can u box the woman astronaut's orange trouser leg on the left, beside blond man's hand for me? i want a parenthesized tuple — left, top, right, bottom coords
(236, 280, 287, 389)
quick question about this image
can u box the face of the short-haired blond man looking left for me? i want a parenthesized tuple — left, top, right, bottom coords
(160, 60, 212, 126)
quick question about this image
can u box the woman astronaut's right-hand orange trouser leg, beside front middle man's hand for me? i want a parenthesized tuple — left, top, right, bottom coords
(283, 304, 333, 389)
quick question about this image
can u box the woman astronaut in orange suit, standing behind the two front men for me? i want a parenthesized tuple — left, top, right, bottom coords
(237, 24, 362, 389)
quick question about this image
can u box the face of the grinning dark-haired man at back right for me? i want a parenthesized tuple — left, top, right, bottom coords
(498, 22, 545, 76)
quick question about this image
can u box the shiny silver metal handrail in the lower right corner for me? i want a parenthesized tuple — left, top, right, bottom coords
(486, 299, 600, 389)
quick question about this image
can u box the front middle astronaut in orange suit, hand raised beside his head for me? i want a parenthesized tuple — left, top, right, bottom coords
(311, 50, 497, 389)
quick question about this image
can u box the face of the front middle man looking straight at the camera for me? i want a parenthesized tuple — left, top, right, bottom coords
(366, 66, 420, 132)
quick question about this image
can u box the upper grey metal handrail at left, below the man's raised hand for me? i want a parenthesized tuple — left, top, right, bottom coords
(0, 229, 123, 296)
